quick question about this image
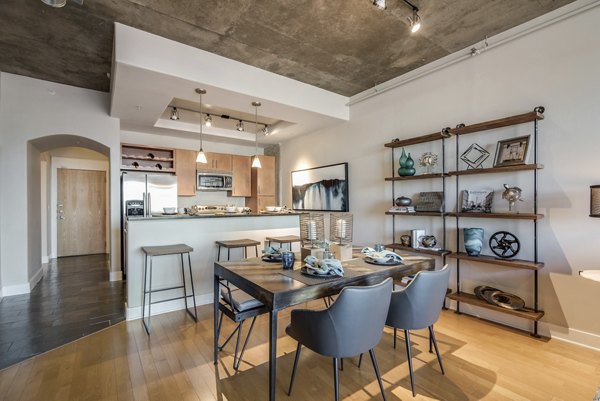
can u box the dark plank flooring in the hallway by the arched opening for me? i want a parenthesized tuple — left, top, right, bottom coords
(0, 254, 125, 369)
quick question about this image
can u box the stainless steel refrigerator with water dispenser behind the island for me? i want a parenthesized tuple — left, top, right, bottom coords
(121, 172, 177, 274)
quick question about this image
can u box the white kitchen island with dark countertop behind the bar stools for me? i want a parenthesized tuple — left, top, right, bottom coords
(125, 213, 300, 320)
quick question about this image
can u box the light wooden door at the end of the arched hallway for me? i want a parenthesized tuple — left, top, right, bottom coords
(57, 168, 106, 257)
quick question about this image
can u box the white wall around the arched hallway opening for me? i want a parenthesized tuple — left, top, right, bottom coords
(0, 73, 120, 296)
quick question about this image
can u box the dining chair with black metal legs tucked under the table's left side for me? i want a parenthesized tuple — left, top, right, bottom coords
(217, 280, 269, 370)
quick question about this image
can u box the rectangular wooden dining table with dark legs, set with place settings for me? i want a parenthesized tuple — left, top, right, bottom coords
(214, 254, 435, 401)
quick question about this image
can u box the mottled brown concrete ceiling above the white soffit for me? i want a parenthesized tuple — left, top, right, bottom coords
(0, 0, 572, 96)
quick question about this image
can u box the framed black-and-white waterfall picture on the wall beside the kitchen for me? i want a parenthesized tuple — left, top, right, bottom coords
(292, 163, 350, 212)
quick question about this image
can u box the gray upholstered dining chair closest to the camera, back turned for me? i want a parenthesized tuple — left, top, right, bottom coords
(286, 278, 393, 401)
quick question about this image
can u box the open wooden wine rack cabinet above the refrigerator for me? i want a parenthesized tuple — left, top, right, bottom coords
(121, 144, 175, 173)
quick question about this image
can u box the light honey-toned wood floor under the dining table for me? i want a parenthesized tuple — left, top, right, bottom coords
(0, 303, 600, 401)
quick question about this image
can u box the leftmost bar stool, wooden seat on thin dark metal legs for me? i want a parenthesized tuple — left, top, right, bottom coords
(142, 244, 198, 335)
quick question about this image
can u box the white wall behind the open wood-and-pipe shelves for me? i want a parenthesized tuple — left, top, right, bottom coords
(281, 3, 600, 348)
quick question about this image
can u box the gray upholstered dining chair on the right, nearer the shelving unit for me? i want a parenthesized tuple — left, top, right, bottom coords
(385, 265, 450, 397)
